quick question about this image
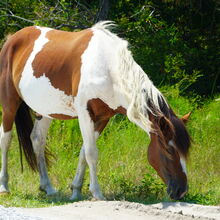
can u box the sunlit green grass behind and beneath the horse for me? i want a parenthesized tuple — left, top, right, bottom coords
(0, 89, 220, 207)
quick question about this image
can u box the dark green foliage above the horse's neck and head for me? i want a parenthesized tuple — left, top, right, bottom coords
(112, 0, 220, 95)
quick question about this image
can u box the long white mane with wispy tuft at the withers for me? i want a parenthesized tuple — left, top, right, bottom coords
(93, 21, 166, 132)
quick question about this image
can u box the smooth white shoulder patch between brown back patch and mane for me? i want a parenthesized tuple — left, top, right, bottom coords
(75, 30, 123, 109)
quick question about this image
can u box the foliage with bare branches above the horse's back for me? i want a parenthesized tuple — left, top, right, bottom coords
(0, 0, 97, 39)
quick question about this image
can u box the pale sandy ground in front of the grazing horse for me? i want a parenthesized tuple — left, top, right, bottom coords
(20, 201, 220, 220)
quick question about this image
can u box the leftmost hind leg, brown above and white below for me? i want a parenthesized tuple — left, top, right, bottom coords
(0, 108, 16, 193)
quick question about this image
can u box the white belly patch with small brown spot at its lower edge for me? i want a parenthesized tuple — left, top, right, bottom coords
(19, 74, 77, 119)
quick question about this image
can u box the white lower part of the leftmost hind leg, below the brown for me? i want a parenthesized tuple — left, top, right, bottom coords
(0, 125, 11, 194)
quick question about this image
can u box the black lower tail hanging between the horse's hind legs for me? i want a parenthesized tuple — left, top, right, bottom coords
(15, 102, 38, 171)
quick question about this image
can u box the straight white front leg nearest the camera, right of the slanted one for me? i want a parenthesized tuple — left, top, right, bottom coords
(71, 109, 105, 200)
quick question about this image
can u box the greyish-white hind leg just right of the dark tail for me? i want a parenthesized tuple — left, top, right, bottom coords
(31, 117, 57, 195)
